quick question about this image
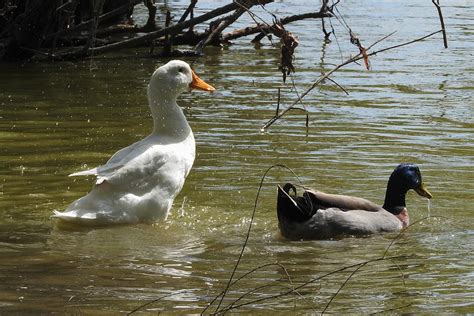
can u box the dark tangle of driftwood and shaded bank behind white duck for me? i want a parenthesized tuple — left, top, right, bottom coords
(0, 0, 331, 61)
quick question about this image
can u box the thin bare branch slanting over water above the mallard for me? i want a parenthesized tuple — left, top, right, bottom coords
(260, 30, 443, 131)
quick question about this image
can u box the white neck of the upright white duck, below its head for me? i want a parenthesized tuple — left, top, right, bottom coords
(148, 87, 192, 139)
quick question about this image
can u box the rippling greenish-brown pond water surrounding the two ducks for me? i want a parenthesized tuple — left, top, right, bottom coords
(0, 1, 474, 314)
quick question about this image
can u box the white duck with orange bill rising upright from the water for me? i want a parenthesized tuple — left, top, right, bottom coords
(53, 60, 215, 225)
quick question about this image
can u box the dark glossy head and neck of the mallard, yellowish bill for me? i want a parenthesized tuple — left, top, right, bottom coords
(383, 163, 433, 213)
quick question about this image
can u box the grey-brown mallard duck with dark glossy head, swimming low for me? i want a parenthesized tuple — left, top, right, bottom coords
(277, 164, 432, 240)
